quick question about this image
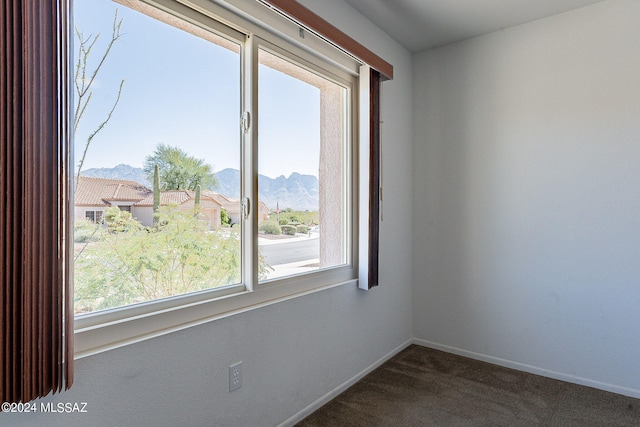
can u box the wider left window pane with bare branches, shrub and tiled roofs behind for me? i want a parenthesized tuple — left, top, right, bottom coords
(74, 0, 241, 313)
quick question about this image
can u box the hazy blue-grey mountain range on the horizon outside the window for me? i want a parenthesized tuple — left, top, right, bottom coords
(82, 164, 320, 211)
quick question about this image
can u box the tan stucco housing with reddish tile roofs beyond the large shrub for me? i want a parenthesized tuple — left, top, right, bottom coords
(75, 176, 222, 229)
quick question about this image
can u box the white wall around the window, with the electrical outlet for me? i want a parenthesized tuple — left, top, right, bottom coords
(0, 0, 412, 426)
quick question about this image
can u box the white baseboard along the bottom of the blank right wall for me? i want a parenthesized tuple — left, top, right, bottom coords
(413, 338, 640, 399)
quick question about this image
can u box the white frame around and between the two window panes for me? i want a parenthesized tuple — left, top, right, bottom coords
(74, 0, 368, 359)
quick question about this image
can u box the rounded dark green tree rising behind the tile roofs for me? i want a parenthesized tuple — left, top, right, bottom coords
(144, 144, 218, 191)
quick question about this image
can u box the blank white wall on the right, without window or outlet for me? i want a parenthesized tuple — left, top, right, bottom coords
(413, 0, 640, 397)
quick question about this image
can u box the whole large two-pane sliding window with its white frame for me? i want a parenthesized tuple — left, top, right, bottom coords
(74, 0, 359, 353)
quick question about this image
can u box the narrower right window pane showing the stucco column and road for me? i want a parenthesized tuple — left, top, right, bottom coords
(258, 49, 349, 280)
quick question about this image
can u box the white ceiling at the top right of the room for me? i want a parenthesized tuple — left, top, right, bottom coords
(346, 0, 603, 52)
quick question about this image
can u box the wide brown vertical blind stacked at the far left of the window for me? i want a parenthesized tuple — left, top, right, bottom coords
(0, 0, 73, 402)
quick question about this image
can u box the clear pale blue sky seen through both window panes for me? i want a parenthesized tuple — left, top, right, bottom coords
(74, 0, 320, 177)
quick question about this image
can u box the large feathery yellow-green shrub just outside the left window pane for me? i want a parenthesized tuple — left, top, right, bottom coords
(75, 206, 251, 311)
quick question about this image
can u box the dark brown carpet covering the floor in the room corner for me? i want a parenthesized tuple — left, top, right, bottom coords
(297, 345, 640, 427)
